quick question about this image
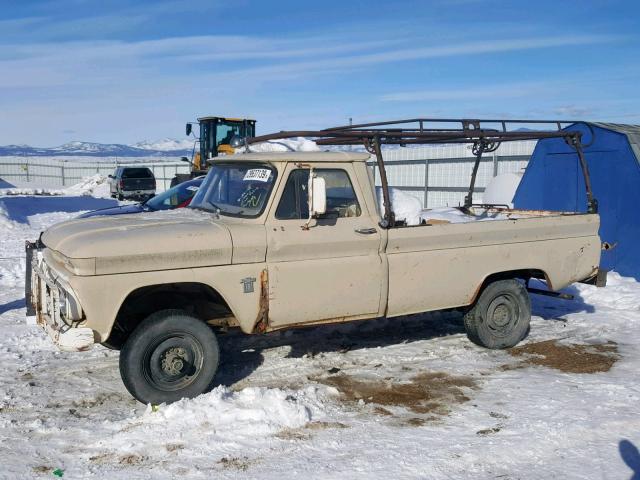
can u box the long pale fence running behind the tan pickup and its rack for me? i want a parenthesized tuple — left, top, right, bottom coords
(0, 141, 536, 203)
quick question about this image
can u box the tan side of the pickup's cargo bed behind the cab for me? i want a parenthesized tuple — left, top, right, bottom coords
(386, 209, 601, 316)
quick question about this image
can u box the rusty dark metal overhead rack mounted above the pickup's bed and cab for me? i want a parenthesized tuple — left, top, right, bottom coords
(244, 118, 598, 228)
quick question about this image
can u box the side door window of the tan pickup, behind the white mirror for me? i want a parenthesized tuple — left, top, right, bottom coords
(276, 169, 362, 220)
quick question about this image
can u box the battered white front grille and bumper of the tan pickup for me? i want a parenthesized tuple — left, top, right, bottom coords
(25, 249, 94, 352)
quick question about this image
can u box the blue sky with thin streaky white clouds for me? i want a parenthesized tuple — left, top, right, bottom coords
(0, 0, 640, 146)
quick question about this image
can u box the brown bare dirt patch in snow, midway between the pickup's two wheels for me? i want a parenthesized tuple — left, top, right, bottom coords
(316, 372, 476, 415)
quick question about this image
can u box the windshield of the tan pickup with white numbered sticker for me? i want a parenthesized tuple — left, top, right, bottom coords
(189, 162, 277, 217)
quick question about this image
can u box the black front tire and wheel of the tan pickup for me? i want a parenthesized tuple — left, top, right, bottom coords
(120, 310, 220, 405)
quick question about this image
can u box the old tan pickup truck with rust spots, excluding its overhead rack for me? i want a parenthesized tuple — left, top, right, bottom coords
(29, 122, 601, 404)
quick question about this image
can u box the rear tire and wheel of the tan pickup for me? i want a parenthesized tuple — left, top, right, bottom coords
(464, 279, 531, 349)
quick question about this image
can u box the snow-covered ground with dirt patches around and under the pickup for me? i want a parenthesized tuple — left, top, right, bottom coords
(0, 189, 640, 479)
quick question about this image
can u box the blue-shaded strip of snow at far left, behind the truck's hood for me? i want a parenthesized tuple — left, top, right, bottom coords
(0, 195, 118, 223)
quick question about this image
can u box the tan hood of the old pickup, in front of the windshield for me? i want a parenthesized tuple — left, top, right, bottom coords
(42, 209, 232, 275)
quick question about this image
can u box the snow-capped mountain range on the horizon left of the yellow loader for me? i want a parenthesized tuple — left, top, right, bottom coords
(0, 138, 193, 157)
